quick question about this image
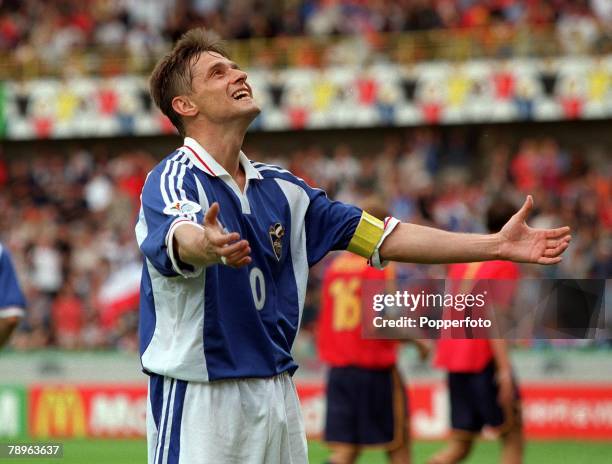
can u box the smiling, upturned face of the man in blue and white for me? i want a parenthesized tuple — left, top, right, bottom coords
(189, 52, 260, 124)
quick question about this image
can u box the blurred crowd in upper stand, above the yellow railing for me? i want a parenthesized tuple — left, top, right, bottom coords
(0, 0, 612, 72)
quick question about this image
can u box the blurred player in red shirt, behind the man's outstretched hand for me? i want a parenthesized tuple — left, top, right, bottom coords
(428, 200, 523, 464)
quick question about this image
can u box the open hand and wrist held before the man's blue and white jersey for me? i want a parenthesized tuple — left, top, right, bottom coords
(174, 202, 251, 268)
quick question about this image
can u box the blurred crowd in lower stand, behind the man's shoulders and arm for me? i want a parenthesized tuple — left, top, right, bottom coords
(0, 129, 612, 351)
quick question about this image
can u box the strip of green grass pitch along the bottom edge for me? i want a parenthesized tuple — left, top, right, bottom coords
(0, 440, 612, 464)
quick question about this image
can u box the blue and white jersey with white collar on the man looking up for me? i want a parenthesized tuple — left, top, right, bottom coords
(136, 137, 364, 381)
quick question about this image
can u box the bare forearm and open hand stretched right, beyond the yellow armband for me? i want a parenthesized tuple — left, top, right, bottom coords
(380, 195, 571, 264)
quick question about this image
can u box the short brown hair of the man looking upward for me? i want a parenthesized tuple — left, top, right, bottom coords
(149, 27, 228, 136)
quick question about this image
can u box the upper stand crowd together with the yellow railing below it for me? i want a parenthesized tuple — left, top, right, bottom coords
(0, 0, 612, 77)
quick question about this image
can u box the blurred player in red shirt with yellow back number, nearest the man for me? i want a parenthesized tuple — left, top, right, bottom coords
(317, 199, 429, 464)
